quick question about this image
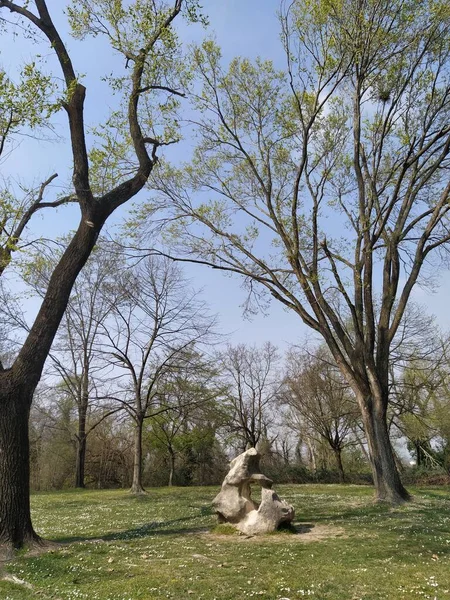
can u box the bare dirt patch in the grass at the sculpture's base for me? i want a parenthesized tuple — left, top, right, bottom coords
(203, 523, 346, 544)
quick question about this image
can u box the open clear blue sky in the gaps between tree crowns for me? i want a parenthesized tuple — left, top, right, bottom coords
(0, 0, 450, 347)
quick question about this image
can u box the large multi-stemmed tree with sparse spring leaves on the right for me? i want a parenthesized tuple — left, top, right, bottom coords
(147, 0, 450, 503)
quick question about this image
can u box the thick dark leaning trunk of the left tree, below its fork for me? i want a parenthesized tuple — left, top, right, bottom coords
(0, 221, 105, 548)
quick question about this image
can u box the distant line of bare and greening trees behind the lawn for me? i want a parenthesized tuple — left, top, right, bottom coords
(19, 242, 450, 494)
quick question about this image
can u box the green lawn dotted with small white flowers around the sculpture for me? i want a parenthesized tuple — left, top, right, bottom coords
(0, 485, 450, 600)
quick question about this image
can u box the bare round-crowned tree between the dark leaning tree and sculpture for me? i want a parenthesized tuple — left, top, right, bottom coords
(103, 257, 214, 494)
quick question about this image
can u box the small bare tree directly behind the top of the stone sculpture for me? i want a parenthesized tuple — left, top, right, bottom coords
(219, 342, 282, 452)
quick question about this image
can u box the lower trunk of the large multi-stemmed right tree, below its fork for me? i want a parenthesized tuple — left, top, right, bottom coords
(360, 398, 411, 504)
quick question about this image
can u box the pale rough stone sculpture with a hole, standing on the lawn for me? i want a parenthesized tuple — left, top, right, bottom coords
(213, 448, 295, 535)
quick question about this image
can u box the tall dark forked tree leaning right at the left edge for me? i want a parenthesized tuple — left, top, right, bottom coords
(0, 0, 200, 550)
